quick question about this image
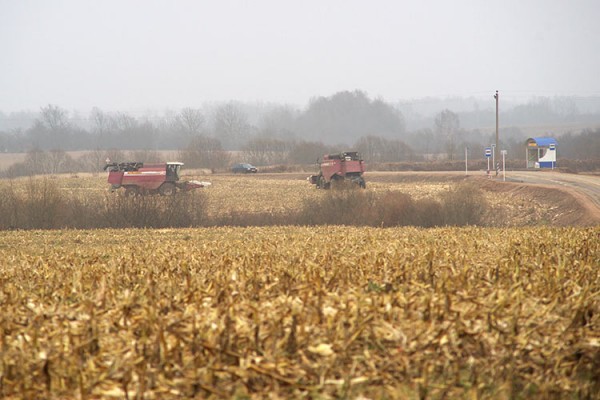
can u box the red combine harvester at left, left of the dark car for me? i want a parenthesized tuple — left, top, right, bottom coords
(104, 162, 210, 196)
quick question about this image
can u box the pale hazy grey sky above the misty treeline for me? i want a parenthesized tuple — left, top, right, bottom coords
(0, 0, 600, 112)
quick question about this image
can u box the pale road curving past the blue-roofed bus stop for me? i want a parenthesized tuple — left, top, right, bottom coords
(506, 171, 600, 209)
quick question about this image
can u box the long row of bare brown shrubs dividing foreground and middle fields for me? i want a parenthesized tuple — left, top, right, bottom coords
(0, 178, 487, 229)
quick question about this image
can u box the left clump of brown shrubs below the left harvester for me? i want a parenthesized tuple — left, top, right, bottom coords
(0, 178, 206, 229)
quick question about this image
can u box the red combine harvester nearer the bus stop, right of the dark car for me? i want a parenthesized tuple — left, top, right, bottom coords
(308, 151, 367, 189)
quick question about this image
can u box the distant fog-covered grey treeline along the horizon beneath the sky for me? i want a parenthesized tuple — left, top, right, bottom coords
(0, 91, 600, 171)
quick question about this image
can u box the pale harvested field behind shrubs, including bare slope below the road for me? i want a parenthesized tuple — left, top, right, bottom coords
(0, 170, 599, 228)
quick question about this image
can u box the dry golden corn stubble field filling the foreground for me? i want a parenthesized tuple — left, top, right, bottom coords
(0, 226, 600, 399)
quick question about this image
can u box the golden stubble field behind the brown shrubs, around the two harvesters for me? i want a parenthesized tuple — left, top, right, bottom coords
(0, 170, 572, 226)
